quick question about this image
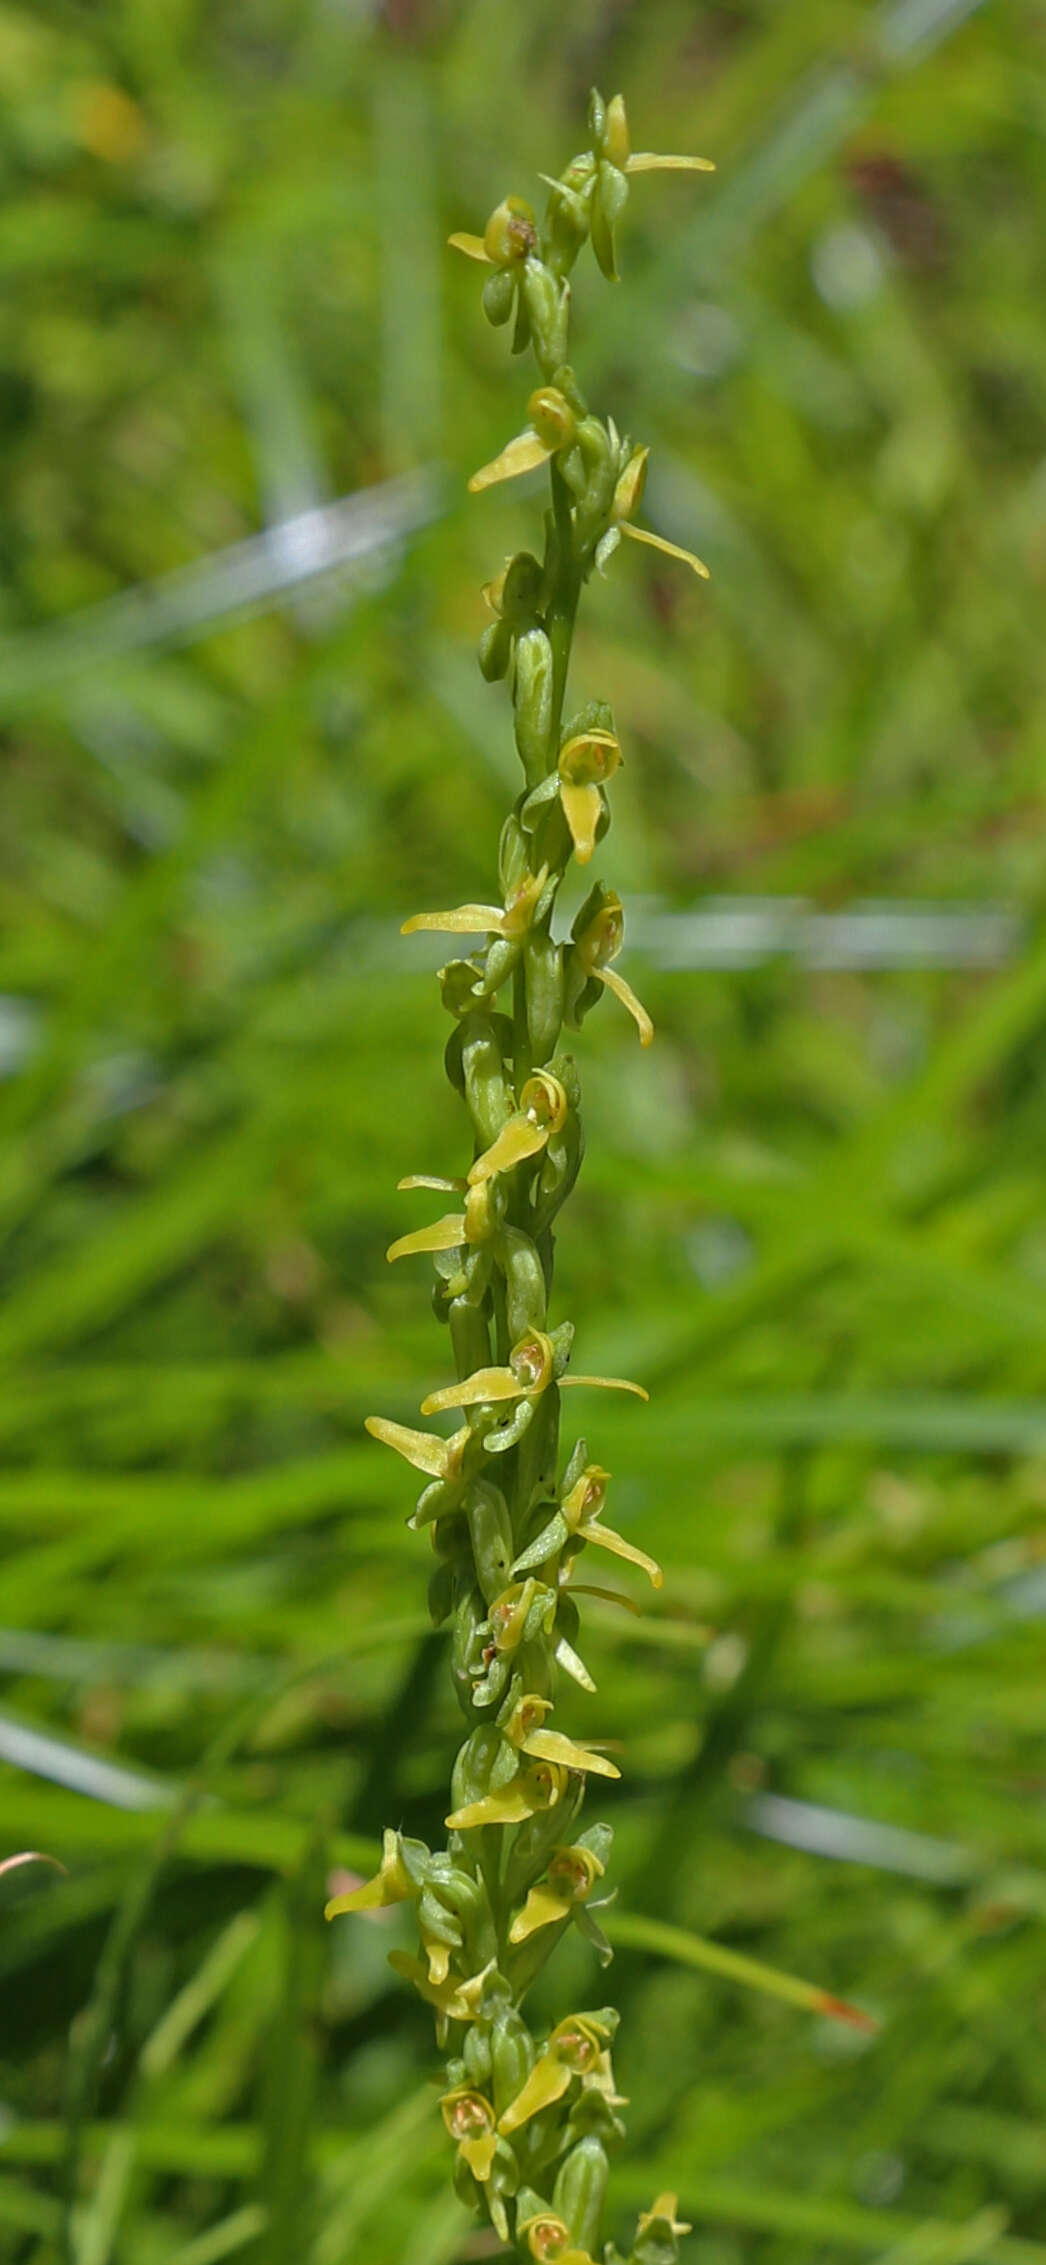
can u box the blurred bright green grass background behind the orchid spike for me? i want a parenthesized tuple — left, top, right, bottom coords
(0, 0, 1046, 2265)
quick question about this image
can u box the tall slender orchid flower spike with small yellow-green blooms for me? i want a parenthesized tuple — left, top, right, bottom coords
(339, 93, 709, 2265)
